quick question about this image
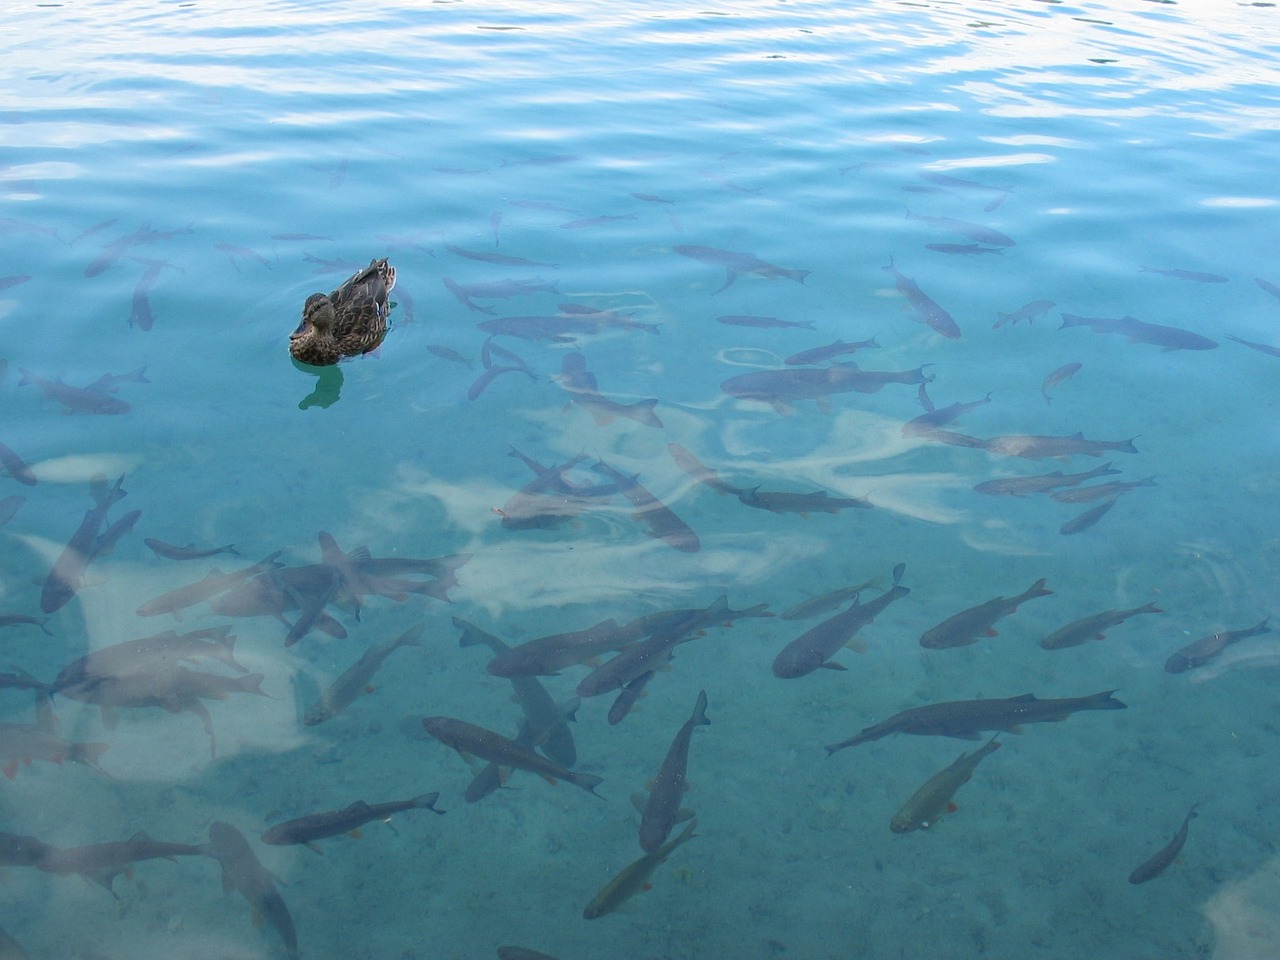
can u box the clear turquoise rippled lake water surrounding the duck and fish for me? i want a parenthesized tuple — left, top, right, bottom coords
(0, 0, 1280, 960)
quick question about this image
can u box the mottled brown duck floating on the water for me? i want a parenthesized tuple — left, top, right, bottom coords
(289, 257, 396, 366)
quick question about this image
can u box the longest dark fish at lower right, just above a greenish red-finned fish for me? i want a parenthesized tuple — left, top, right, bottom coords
(826, 690, 1128, 756)
